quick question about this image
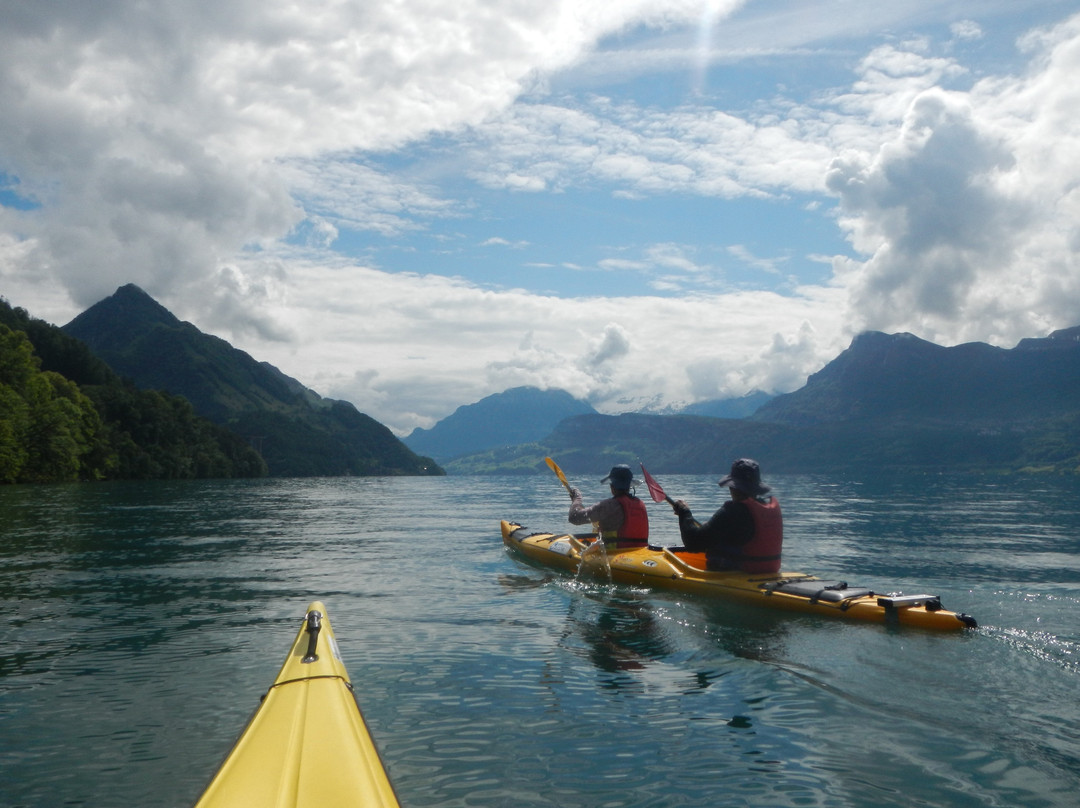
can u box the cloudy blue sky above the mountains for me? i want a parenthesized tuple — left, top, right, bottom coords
(0, 0, 1080, 434)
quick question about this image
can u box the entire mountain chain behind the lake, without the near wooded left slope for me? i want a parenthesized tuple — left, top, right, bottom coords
(12, 285, 1080, 476)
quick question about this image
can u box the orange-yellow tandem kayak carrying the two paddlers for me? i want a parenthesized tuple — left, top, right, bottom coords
(502, 521, 976, 630)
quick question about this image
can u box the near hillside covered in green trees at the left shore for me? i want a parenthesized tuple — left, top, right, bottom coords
(0, 299, 267, 483)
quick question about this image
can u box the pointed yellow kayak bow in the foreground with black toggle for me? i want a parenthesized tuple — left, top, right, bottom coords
(195, 601, 399, 808)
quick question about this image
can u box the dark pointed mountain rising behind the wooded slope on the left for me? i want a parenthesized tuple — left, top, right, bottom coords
(62, 284, 444, 476)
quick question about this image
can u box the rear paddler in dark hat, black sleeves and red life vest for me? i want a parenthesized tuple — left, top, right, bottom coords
(672, 458, 784, 573)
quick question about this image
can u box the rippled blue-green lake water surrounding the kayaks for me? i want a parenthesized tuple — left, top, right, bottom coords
(0, 470, 1080, 808)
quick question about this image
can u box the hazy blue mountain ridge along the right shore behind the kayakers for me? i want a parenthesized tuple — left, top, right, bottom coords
(436, 327, 1080, 474)
